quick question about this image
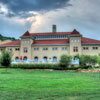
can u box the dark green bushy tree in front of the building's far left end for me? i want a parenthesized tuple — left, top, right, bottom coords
(0, 50, 12, 67)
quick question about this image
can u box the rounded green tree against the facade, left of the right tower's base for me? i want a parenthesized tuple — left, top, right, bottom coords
(59, 55, 72, 67)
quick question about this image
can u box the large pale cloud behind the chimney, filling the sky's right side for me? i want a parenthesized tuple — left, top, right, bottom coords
(30, 0, 100, 38)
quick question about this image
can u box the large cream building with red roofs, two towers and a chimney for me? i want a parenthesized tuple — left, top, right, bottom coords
(0, 25, 100, 62)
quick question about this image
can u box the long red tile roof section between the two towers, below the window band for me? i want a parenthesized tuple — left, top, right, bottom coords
(33, 39, 69, 45)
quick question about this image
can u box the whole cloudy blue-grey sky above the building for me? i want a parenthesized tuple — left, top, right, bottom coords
(0, 0, 100, 40)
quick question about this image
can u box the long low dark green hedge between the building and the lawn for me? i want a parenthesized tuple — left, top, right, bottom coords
(0, 64, 91, 70)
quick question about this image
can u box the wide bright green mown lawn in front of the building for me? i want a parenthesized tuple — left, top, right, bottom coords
(0, 69, 100, 100)
